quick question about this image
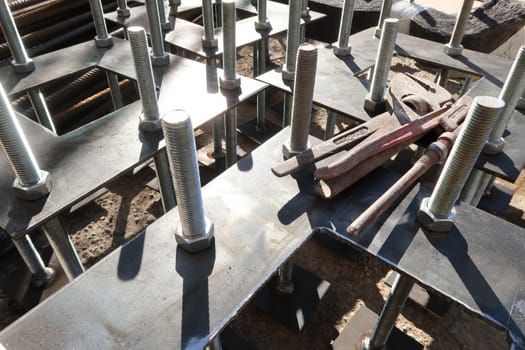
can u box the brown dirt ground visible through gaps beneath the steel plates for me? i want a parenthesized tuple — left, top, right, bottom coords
(0, 33, 525, 350)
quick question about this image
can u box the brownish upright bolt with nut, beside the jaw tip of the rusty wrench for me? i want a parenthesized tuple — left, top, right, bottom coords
(283, 44, 317, 159)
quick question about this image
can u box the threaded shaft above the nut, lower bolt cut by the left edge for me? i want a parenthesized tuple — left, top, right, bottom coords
(0, 85, 41, 187)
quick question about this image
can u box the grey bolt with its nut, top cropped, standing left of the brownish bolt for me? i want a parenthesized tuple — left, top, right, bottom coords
(219, 0, 241, 90)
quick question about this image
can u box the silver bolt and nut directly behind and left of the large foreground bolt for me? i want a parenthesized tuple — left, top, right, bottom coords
(128, 27, 161, 131)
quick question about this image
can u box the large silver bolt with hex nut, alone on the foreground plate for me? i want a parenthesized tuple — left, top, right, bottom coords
(162, 110, 214, 252)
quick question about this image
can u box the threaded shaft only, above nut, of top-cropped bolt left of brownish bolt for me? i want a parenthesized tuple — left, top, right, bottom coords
(222, 0, 237, 80)
